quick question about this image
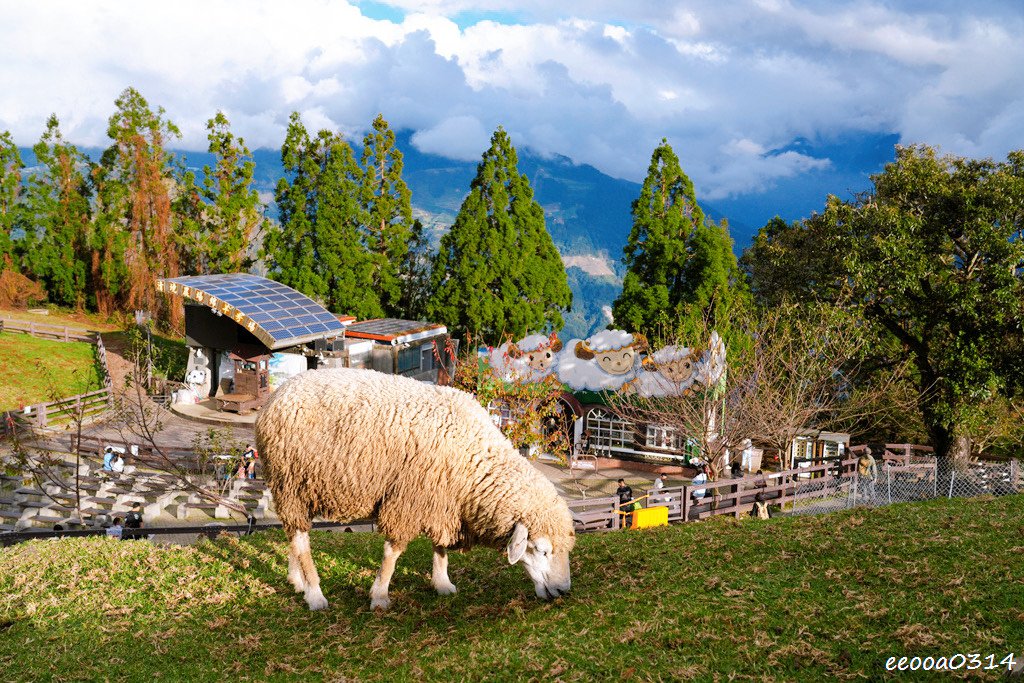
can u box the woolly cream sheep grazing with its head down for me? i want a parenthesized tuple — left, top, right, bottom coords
(256, 370, 575, 609)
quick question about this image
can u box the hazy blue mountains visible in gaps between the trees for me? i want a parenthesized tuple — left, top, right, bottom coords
(22, 132, 896, 339)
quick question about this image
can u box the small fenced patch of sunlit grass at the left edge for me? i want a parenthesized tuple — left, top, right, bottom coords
(0, 332, 103, 411)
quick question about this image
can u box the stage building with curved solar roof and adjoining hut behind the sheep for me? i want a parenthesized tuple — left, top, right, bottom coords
(157, 273, 458, 410)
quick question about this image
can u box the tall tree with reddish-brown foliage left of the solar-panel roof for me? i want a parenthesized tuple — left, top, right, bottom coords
(90, 88, 182, 328)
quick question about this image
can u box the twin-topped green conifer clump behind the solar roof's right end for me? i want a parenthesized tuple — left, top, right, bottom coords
(263, 113, 384, 317)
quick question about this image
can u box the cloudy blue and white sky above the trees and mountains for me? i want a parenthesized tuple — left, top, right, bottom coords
(0, 0, 1024, 219)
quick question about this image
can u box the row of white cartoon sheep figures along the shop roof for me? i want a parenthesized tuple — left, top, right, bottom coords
(490, 330, 725, 397)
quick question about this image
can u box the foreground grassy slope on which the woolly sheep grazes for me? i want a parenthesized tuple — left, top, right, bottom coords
(0, 496, 1024, 681)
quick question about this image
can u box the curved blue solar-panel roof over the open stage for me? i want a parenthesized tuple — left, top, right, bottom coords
(157, 272, 345, 349)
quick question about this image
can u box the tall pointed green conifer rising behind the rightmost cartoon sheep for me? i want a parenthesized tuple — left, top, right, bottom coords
(611, 139, 705, 338)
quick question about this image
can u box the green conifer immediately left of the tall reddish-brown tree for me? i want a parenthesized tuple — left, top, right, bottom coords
(25, 115, 92, 308)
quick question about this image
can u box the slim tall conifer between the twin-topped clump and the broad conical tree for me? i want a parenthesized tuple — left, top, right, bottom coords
(359, 114, 413, 316)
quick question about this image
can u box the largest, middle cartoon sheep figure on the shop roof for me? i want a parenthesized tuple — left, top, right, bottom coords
(558, 330, 647, 391)
